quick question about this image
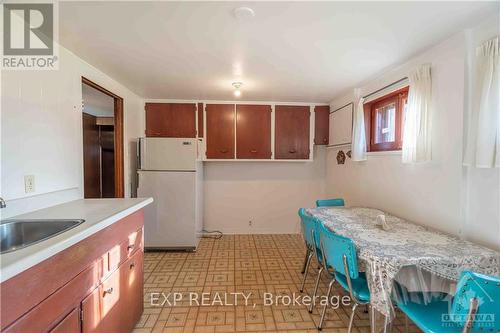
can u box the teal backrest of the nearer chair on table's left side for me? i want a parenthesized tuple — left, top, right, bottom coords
(320, 224, 359, 279)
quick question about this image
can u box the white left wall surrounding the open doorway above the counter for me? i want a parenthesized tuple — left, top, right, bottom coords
(0, 47, 144, 217)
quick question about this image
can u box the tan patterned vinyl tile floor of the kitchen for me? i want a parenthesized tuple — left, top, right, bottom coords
(134, 234, 420, 333)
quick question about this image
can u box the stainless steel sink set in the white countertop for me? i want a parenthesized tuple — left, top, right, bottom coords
(0, 219, 84, 253)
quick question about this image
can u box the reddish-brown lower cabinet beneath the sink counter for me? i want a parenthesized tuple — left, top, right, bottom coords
(0, 210, 144, 333)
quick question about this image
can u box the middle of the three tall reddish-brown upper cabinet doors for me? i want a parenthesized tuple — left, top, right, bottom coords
(236, 105, 271, 159)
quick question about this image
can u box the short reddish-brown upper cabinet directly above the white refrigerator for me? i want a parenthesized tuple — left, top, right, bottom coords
(146, 103, 196, 138)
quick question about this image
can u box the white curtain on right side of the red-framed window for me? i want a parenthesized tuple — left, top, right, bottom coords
(402, 64, 432, 163)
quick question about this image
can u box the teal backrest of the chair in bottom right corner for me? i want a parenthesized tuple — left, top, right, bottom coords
(450, 271, 500, 332)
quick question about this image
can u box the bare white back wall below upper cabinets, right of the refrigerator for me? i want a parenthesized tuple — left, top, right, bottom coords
(204, 146, 326, 234)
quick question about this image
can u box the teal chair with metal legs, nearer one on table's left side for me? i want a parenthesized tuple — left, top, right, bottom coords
(318, 224, 374, 333)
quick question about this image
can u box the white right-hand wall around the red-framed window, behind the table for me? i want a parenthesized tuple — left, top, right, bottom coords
(326, 16, 500, 248)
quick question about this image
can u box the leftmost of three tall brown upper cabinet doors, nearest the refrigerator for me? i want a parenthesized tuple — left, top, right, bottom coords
(205, 104, 234, 159)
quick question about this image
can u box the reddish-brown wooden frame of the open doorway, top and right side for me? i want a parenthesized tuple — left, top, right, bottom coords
(82, 76, 125, 198)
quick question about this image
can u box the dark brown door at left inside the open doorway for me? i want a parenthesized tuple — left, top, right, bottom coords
(82, 113, 101, 198)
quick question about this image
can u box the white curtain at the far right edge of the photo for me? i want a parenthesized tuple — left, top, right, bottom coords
(464, 37, 500, 168)
